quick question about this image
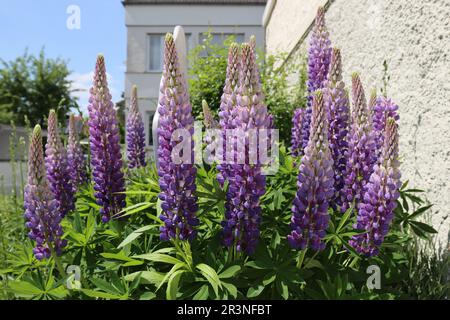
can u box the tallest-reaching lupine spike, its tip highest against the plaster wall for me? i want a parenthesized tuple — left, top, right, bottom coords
(302, 7, 331, 152)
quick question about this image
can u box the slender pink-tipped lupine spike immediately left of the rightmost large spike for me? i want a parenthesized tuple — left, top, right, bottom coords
(341, 73, 376, 211)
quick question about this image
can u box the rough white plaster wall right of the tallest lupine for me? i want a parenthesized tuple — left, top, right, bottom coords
(266, 0, 450, 243)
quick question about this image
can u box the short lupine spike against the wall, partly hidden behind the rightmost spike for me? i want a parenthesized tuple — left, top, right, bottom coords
(373, 96, 400, 155)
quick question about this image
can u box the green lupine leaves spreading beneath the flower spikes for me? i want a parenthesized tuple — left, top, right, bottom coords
(0, 146, 449, 299)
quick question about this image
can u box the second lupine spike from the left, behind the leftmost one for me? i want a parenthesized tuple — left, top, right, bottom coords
(45, 110, 75, 218)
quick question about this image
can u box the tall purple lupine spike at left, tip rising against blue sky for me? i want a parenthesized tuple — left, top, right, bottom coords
(88, 55, 125, 222)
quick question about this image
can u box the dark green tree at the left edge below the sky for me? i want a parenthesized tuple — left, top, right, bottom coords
(0, 50, 78, 125)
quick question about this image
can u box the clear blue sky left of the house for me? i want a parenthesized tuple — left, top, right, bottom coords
(0, 0, 126, 110)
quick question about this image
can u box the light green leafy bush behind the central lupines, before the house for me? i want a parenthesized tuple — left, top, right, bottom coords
(188, 33, 306, 145)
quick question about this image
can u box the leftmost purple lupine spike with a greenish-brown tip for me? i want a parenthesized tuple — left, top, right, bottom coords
(24, 125, 67, 260)
